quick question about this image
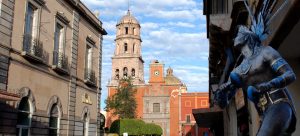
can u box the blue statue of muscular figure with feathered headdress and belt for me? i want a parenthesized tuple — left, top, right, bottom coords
(215, 0, 296, 136)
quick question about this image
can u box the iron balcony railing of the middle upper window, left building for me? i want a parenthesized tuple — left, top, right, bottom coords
(52, 51, 69, 74)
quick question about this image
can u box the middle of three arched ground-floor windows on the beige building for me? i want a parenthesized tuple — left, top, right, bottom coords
(49, 104, 60, 136)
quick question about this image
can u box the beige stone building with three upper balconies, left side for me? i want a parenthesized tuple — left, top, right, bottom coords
(0, 0, 106, 136)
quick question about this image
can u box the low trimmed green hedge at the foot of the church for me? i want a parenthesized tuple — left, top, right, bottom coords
(110, 119, 163, 136)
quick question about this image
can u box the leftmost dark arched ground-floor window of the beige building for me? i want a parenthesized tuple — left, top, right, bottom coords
(17, 97, 32, 136)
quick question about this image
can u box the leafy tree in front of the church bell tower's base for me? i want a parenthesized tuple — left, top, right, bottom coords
(105, 78, 137, 119)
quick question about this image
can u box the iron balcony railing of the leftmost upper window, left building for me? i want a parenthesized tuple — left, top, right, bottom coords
(21, 34, 48, 63)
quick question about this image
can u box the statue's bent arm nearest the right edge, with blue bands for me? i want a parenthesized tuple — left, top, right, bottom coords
(258, 46, 296, 91)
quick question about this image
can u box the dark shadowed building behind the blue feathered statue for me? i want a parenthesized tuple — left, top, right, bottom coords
(194, 0, 300, 136)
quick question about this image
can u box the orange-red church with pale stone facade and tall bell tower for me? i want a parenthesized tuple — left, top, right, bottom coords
(106, 11, 209, 136)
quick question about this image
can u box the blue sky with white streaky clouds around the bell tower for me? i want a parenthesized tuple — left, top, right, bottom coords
(81, 0, 208, 109)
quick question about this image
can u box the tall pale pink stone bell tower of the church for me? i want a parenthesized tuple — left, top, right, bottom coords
(110, 10, 145, 86)
